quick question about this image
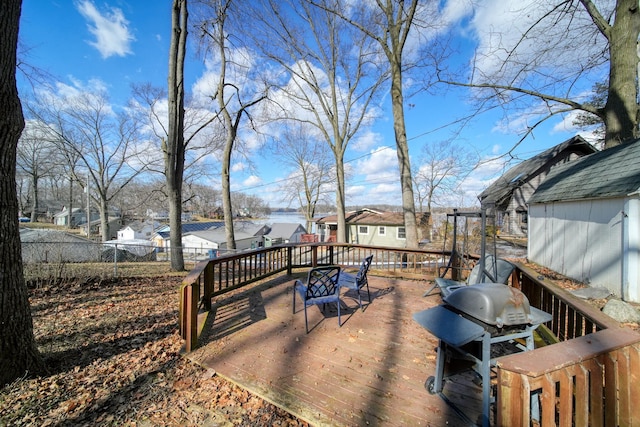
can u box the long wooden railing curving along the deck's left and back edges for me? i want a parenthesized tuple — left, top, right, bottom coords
(179, 243, 448, 352)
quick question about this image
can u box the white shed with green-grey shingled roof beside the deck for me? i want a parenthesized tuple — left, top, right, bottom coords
(528, 140, 640, 302)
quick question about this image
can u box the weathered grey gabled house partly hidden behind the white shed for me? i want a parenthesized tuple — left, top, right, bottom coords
(478, 136, 597, 236)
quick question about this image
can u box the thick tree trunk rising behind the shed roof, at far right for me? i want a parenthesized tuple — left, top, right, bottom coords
(604, 0, 640, 148)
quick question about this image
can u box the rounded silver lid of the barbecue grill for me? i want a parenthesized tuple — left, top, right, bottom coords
(443, 283, 532, 328)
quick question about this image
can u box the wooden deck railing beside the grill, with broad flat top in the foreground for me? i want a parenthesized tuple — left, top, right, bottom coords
(496, 265, 640, 426)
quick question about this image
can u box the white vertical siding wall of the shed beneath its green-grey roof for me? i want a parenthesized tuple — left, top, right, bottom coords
(529, 199, 624, 296)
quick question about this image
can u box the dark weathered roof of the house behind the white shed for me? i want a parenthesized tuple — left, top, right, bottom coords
(478, 136, 597, 206)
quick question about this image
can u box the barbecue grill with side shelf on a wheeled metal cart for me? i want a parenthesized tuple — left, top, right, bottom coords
(413, 283, 551, 426)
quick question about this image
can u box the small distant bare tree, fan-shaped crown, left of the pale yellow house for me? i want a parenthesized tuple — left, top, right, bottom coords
(272, 122, 336, 230)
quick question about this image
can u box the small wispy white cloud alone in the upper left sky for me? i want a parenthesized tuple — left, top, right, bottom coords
(76, 0, 135, 59)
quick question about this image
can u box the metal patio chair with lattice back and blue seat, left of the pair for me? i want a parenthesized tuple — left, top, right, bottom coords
(293, 266, 342, 333)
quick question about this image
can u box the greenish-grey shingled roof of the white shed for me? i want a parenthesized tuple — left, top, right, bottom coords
(529, 140, 640, 203)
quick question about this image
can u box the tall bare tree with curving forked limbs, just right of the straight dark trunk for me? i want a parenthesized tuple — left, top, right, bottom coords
(195, 0, 266, 249)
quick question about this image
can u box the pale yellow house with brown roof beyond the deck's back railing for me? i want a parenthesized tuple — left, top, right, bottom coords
(316, 208, 427, 248)
